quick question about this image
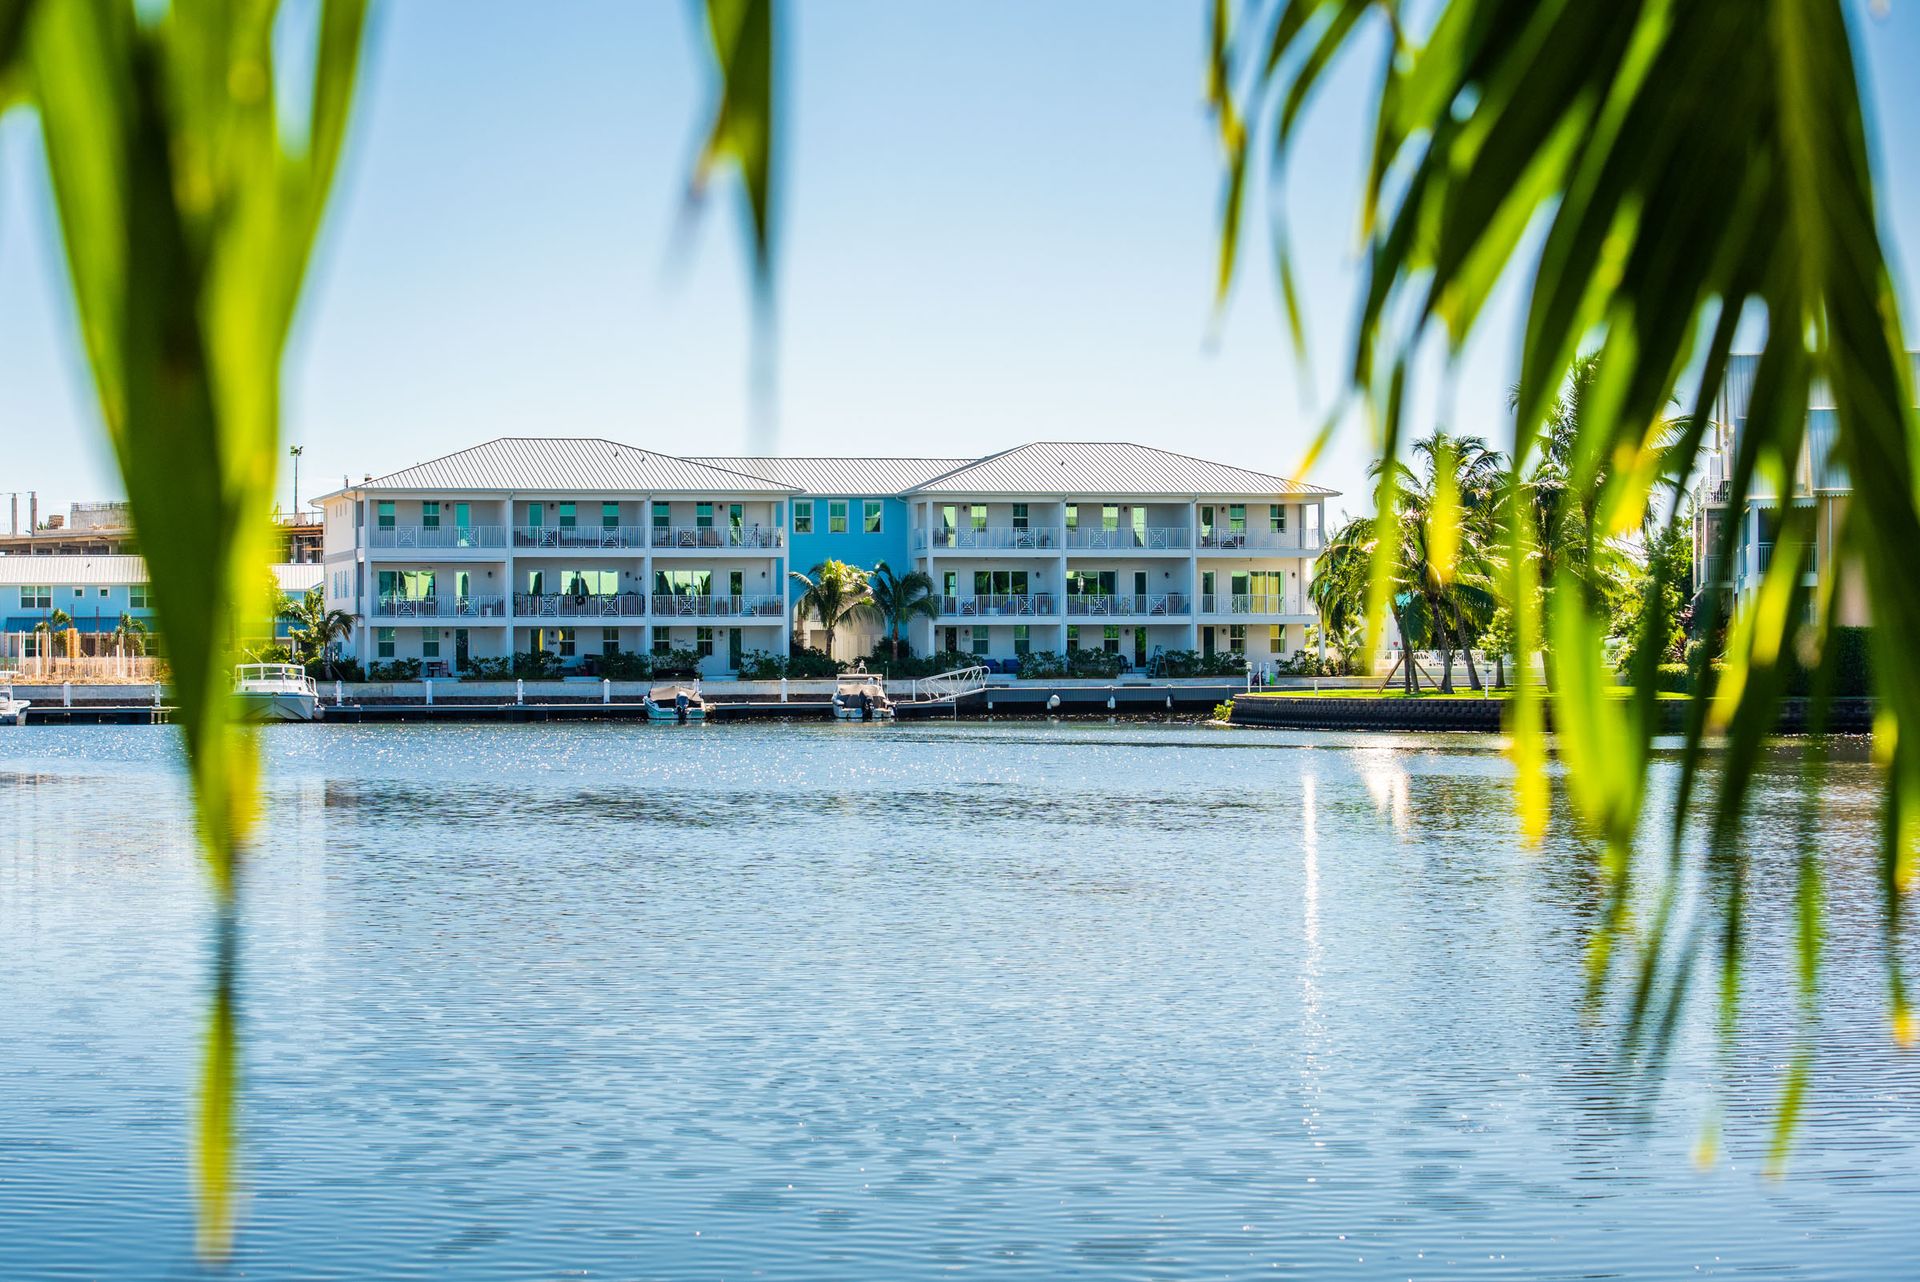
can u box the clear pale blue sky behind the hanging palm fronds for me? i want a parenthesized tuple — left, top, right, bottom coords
(0, 0, 1920, 520)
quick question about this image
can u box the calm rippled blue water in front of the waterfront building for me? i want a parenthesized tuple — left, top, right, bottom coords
(0, 724, 1920, 1282)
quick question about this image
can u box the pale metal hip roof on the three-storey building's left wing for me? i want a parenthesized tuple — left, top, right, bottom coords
(336, 436, 791, 495)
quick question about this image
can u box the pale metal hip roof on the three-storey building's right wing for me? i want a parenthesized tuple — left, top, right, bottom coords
(912, 441, 1338, 499)
